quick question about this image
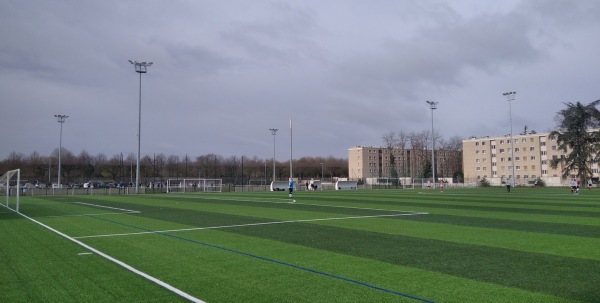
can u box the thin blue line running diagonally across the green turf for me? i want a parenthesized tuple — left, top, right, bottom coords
(36, 202, 435, 303)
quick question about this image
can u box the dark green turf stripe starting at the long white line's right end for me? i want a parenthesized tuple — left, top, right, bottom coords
(394, 214, 600, 238)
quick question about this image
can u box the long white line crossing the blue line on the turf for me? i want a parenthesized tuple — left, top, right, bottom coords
(73, 212, 428, 239)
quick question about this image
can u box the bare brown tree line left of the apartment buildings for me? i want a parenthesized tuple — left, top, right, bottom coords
(0, 147, 348, 185)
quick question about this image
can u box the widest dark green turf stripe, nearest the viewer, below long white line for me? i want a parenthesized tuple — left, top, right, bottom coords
(226, 223, 600, 302)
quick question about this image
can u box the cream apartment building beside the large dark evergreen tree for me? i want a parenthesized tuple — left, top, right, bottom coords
(463, 133, 598, 186)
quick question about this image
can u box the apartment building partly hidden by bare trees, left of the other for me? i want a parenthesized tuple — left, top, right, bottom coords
(348, 146, 463, 180)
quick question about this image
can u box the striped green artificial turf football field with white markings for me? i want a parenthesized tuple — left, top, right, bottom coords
(0, 188, 600, 303)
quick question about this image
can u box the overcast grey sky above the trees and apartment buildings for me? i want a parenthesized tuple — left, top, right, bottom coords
(0, 0, 600, 161)
